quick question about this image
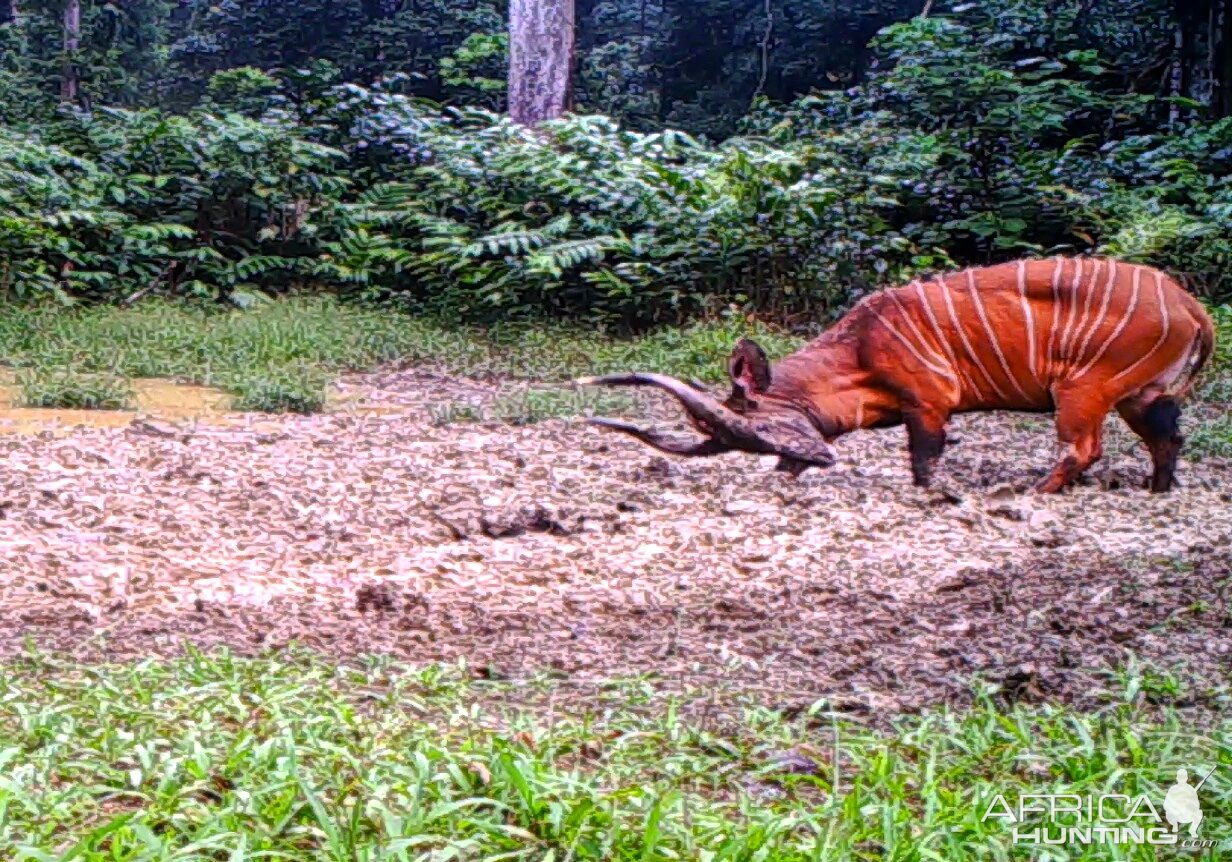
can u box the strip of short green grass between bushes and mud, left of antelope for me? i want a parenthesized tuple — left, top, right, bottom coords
(0, 297, 798, 416)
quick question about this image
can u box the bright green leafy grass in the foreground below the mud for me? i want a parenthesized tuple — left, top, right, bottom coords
(0, 653, 1232, 862)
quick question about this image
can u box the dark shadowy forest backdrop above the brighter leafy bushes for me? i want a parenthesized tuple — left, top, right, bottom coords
(0, 0, 1232, 137)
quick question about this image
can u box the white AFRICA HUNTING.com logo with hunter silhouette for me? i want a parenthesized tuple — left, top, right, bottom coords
(982, 766, 1217, 850)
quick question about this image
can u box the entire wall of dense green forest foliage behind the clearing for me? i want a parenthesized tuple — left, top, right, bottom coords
(0, 0, 1232, 329)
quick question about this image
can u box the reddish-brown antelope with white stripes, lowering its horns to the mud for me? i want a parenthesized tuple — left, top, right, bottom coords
(577, 257, 1215, 493)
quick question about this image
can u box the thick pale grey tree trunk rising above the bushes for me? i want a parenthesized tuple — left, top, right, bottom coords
(509, 0, 574, 126)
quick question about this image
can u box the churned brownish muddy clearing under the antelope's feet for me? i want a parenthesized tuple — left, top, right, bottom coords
(0, 371, 1232, 714)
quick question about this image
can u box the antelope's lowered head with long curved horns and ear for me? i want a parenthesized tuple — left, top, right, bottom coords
(574, 339, 834, 475)
